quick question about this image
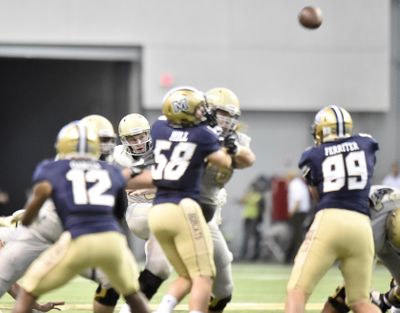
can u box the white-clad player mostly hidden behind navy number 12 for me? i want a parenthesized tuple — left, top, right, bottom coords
(0, 115, 115, 298)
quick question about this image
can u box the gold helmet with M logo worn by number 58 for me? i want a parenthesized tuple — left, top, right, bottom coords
(162, 87, 206, 126)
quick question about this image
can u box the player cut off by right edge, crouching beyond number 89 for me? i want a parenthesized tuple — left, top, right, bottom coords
(323, 185, 400, 313)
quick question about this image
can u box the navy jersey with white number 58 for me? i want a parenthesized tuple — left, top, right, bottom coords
(151, 119, 221, 204)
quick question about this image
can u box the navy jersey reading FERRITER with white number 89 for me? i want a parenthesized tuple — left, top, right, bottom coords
(299, 134, 379, 215)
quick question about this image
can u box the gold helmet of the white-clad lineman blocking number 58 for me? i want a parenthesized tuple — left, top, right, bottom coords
(206, 88, 241, 134)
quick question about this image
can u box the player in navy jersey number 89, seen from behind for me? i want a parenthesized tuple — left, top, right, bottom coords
(285, 106, 379, 313)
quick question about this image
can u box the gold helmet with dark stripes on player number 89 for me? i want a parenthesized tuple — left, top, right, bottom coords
(312, 105, 353, 145)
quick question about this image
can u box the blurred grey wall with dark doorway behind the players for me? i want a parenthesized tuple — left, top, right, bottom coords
(0, 0, 400, 260)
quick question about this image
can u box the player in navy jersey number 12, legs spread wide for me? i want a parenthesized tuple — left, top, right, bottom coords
(13, 122, 149, 313)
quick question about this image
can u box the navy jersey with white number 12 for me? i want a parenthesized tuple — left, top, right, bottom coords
(33, 159, 126, 238)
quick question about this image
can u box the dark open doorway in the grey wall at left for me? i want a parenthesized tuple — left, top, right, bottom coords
(0, 58, 131, 215)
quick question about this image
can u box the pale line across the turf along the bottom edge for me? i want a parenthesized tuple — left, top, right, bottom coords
(0, 302, 324, 311)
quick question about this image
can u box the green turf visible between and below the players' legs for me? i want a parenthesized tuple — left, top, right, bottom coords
(0, 263, 390, 313)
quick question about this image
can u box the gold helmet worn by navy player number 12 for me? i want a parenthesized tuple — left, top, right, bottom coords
(55, 121, 100, 159)
